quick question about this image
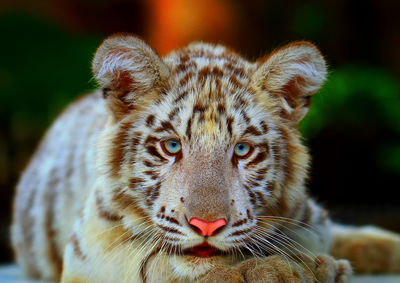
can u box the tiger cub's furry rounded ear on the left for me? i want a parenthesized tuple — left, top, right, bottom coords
(92, 34, 169, 119)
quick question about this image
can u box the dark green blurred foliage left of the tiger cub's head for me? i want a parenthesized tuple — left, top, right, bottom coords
(0, 15, 100, 131)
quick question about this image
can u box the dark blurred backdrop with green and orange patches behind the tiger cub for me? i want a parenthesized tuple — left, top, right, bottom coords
(0, 0, 400, 262)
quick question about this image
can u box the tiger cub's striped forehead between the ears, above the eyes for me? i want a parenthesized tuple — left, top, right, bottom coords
(142, 44, 265, 144)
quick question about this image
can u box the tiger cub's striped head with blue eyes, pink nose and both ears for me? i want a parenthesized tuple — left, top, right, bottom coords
(93, 35, 326, 280)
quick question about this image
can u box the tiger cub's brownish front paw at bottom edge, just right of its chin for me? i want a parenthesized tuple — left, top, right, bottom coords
(237, 255, 351, 283)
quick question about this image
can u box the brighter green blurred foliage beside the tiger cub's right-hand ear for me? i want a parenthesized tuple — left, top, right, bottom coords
(300, 66, 400, 174)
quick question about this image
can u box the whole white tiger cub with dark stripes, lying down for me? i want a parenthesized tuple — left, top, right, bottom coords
(12, 34, 400, 283)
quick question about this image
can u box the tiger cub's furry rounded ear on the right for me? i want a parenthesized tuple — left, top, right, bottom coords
(251, 42, 327, 123)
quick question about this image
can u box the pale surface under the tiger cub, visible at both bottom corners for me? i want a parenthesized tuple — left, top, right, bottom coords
(0, 265, 400, 283)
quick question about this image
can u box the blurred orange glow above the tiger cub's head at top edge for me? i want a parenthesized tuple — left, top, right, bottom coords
(147, 0, 234, 54)
